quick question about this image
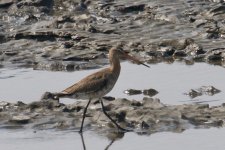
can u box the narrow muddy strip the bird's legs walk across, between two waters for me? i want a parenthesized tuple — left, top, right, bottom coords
(0, 98, 225, 134)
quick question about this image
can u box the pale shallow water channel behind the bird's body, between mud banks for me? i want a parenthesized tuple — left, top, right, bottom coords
(0, 62, 225, 105)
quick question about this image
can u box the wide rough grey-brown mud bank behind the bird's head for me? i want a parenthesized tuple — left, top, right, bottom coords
(0, 0, 225, 71)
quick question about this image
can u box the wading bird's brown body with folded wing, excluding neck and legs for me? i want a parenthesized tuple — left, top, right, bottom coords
(57, 68, 119, 99)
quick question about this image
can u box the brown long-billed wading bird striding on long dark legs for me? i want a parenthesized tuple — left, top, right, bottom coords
(53, 46, 149, 133)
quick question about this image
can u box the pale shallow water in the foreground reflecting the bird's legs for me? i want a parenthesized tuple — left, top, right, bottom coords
(0, 128, 225, 150)
